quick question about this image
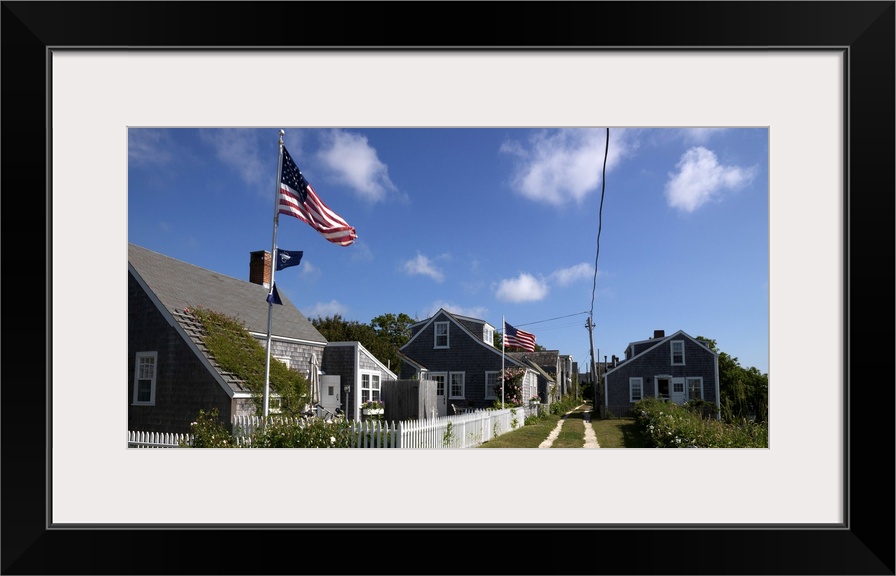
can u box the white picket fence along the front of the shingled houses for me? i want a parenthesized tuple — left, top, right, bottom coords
(128, 406, 538, 448)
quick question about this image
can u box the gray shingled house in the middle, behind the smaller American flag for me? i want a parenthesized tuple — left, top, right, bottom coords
(399, 308, 538, 416)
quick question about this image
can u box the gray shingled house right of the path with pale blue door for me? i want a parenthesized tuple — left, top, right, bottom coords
(603, 330, 720, 416)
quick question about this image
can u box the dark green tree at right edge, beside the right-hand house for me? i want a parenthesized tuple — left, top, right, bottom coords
(697, 336, 768, 422)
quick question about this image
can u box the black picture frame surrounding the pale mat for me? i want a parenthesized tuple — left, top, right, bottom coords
(0, 1, 896, 574)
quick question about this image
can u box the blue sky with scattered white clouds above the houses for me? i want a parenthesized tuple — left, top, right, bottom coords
(128, 127, 769, 372)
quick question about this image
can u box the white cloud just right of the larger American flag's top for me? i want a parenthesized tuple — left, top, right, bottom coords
(317, 130, 396, 202)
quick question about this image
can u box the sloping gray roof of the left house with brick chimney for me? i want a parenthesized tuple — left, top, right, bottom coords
(128, 243, 327, 344)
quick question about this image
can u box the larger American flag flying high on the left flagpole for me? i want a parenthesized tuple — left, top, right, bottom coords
(279, 146, 358, 246)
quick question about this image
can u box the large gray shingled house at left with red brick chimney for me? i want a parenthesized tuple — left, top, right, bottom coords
(127, 244, 327, 433)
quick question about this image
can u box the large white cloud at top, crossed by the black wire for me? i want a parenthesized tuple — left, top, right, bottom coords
(501, 128, 636, 206)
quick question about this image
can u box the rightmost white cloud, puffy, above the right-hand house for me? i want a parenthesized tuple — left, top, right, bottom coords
(666, 146, 756, 212)
